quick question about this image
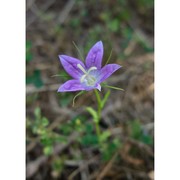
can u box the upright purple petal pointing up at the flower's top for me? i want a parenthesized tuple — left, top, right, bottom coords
(86, 41, 103, 69)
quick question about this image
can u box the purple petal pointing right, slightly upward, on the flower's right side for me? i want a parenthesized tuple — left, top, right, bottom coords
(98, 64, 122, 83)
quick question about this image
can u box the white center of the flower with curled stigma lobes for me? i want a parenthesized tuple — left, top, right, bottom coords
(77, 64, 97, 86)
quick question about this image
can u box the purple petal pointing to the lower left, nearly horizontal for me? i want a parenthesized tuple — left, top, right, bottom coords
(58, 79, 85, 92)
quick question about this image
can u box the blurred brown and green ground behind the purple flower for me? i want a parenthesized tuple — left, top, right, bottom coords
(26, 0, 154, 180)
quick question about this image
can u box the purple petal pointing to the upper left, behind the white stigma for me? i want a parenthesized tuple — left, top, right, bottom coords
(59, 55, 85, 79)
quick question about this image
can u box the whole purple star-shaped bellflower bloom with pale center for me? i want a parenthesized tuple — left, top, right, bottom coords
(58, 41, 121, 92)
